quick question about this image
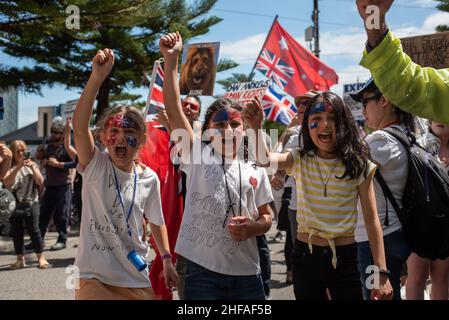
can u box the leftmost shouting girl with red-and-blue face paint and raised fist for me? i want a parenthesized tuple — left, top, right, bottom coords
(73, 49, 178, 300)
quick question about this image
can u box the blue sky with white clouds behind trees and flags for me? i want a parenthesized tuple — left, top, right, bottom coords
(0, 0, 449, 127)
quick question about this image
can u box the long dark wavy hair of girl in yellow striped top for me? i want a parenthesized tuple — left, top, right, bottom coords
(300, 91, 371, 179)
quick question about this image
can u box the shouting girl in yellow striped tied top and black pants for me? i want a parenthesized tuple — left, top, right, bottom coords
(243, 92, 392, 300)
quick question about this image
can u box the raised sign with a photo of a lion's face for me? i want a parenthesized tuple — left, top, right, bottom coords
(179, 42, 220, 96)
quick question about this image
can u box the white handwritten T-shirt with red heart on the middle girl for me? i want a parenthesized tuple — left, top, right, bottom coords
(175, 145, 273, 276)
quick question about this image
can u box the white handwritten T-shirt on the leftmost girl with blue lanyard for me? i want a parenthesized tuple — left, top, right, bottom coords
(75, 148, 164, 288)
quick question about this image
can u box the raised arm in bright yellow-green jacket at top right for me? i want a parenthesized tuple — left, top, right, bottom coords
(356, 0, 449, 124)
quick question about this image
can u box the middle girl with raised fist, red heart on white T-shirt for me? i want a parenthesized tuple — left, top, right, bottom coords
(159, 33, 273, 300)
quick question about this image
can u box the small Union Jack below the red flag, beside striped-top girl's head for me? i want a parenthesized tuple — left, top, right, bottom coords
(262, 86, 298, 125)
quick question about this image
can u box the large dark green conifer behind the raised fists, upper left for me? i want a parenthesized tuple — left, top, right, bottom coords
(0, 0, 236, 120)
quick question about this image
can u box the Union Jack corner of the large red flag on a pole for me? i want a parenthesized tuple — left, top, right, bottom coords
(256, 49, 295, 89)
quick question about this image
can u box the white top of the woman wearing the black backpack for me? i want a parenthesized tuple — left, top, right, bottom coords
(355, 125, 408, 242)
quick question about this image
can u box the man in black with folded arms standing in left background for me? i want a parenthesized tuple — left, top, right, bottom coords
(36, 123, 76, 250)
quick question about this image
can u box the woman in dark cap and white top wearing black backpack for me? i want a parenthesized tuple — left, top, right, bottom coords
(351, 79, 415, 300)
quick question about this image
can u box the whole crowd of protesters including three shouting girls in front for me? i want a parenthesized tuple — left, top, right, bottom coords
(0, 0, 449, 300)
